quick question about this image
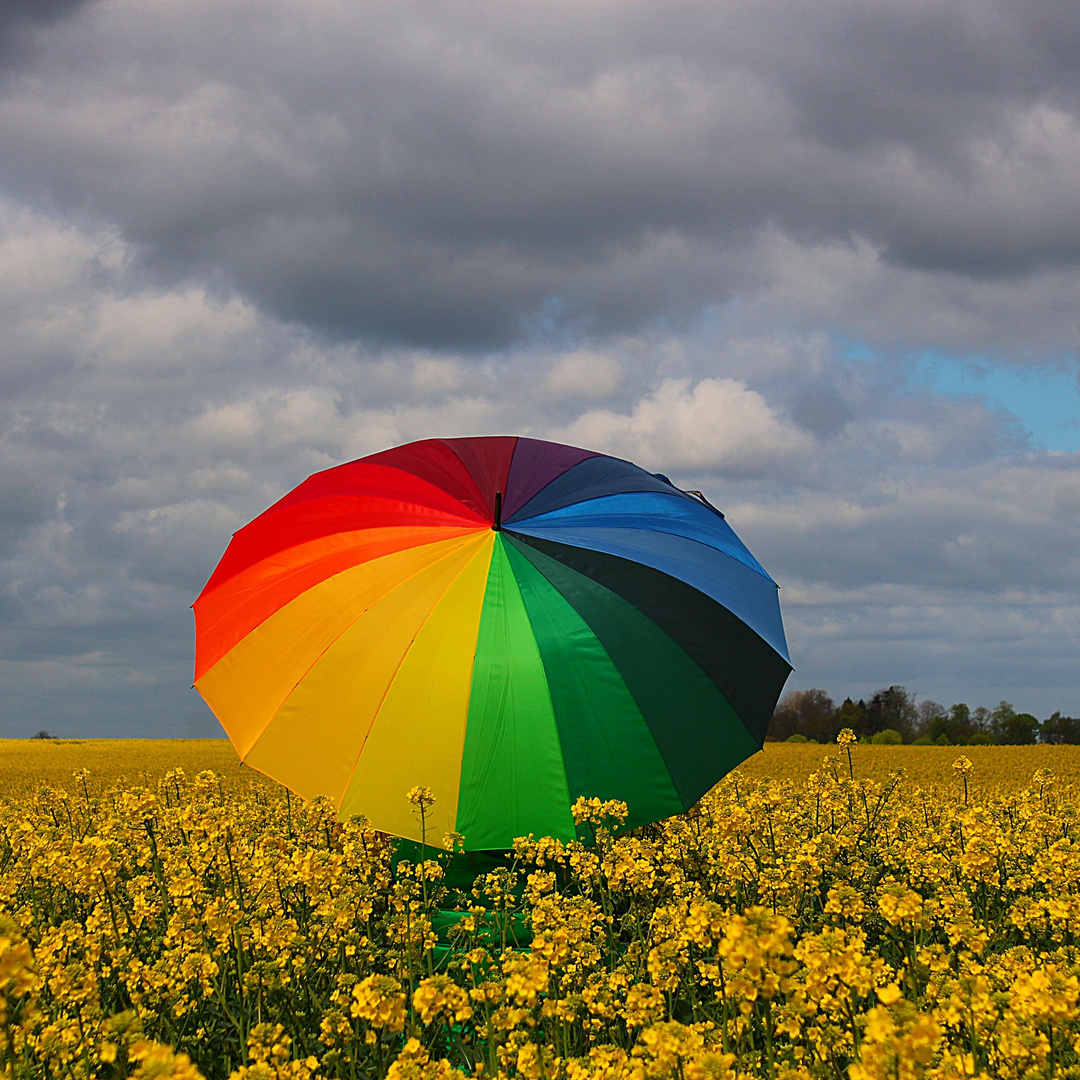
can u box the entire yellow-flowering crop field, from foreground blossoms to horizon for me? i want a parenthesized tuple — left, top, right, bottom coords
(0, 741, 1080, 1080)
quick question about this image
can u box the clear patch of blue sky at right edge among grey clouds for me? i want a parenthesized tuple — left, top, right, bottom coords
(913, 352, 1080, 451)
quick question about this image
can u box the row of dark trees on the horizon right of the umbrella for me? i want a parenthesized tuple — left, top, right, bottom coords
(768, 686, 1080, 746)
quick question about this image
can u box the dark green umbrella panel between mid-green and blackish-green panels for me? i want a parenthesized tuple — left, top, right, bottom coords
(508, 537, 758, 809)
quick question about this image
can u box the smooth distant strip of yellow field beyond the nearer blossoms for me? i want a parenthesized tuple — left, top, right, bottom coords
(0, 739, 1080, 800)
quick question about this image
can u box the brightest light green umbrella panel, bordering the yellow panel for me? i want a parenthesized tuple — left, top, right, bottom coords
(457, 532, 575, 850)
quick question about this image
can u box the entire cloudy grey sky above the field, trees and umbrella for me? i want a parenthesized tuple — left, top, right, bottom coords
(0, 0, 1080, 735)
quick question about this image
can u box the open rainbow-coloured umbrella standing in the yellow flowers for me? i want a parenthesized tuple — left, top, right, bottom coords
(194, 437, 791, 850)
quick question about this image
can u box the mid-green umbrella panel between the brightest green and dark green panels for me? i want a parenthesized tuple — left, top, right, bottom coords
(507, 539, 683, 827)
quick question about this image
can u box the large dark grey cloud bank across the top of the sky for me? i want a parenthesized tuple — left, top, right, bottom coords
(0, 0, 1080, 348)
